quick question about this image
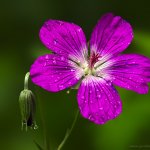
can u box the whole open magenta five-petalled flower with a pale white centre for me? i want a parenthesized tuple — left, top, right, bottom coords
(30, 13, 150, 124)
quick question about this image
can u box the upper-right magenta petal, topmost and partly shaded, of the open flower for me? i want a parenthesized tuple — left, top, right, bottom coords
(90, 13, 133, 57)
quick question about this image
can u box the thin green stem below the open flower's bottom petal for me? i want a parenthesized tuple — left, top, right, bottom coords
(57, 110, 79, 150)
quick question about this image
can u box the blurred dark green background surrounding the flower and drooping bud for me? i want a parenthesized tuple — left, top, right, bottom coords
(0, 0, 150, 150)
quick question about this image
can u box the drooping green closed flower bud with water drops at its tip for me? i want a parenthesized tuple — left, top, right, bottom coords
(19, 89, 37, 131)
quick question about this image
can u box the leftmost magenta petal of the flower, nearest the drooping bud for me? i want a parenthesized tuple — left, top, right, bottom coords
(30, 54, 82, 92)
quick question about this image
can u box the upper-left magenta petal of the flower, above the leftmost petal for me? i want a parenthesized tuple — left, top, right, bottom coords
(39, 20, 87, 61)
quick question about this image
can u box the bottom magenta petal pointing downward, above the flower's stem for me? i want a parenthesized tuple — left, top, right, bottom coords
(77, 76, 122, 124)
